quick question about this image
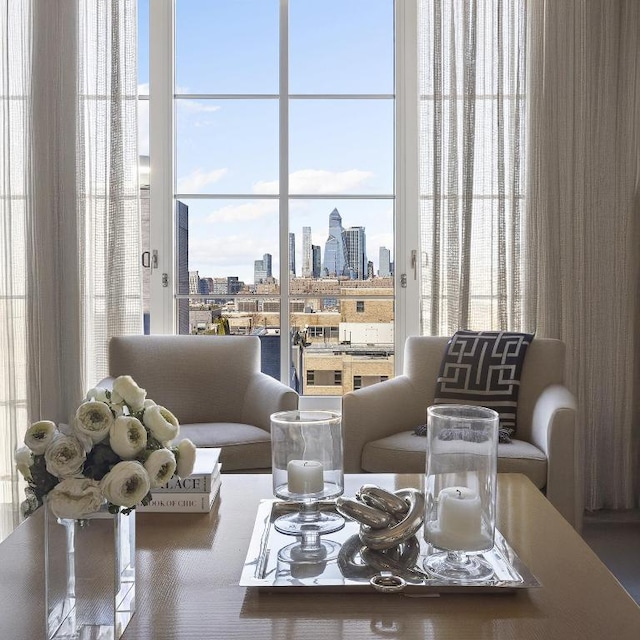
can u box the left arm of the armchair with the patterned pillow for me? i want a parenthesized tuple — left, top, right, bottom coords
(342, 376, 426, 473)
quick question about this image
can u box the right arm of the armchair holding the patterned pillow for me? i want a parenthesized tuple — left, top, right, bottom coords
(531, 384, 583, 532)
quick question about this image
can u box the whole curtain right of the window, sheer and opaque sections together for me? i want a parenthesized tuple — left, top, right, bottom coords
(419, 0, 640, 509)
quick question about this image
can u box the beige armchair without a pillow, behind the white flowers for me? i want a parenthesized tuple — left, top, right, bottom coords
(101, 335, 298, 472)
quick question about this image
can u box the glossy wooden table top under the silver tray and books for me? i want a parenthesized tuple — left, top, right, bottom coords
(0, 474, 640, 640)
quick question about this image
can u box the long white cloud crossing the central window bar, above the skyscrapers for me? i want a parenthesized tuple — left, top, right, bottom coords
(252, 169, 373, 195)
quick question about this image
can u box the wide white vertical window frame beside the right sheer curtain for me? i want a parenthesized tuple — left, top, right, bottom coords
(394, 0, 422, 373)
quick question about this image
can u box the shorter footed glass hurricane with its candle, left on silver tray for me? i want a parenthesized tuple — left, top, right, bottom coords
(271, 410, 344, 559)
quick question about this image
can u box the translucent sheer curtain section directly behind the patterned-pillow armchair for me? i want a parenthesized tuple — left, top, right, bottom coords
(418, 0, 526, 335)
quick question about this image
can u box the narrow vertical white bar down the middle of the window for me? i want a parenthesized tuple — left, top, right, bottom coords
(279, 0, 291, 384)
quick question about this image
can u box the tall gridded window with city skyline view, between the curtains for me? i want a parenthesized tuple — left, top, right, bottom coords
(139, 0, 412, 395)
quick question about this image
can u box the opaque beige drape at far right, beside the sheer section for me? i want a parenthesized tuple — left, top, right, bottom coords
(527, 0, 640, 509)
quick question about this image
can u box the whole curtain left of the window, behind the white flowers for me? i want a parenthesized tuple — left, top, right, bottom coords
(0, 0, 142, 519)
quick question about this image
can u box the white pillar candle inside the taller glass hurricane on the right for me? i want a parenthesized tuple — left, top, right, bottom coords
(427, 487, 491, 551)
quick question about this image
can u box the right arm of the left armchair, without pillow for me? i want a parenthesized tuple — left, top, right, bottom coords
(242, 373, 298, 431)
